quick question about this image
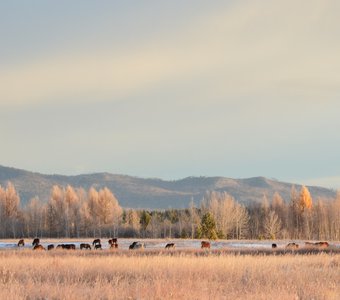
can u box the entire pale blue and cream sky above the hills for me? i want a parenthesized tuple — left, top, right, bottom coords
(0, 0, 340, 188)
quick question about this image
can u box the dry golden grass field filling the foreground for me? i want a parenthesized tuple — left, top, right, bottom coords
(0, 240, 340, 299)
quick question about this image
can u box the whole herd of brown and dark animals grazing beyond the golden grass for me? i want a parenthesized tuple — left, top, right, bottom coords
(14, 238, 329, 250)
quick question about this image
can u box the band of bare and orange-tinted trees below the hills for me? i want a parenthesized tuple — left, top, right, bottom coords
(0, 183, 340, 240)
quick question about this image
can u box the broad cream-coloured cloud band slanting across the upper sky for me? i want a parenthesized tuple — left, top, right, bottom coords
(0, 0, 340, 105)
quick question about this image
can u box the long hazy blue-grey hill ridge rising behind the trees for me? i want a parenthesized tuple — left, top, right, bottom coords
(0, 166, 336, 209)
